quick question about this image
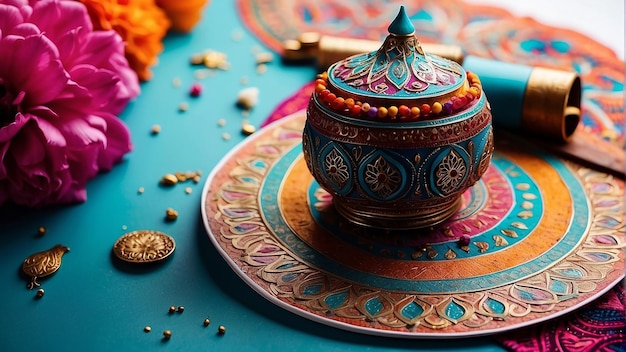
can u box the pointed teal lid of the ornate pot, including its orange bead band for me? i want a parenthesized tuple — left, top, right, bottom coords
(316, 6, 481, 120)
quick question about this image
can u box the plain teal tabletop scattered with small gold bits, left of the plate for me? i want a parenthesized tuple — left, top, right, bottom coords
(0, 0, 503, 351)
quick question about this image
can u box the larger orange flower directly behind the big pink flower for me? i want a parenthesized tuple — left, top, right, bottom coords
(79, 0, 171, 81)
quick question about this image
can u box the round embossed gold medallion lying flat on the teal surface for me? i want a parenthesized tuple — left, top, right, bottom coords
(113, 230, 176, 263)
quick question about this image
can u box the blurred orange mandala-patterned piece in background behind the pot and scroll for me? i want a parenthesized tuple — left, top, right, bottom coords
(238, 0, 625, 146)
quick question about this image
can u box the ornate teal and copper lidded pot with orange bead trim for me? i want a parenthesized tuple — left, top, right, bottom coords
(302, 8, 493, 229)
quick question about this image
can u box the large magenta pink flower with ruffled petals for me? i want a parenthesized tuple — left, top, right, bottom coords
(0, 0, 139, 206)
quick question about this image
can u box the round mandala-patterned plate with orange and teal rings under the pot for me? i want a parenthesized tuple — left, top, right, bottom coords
(202, 111, 625, 338)
